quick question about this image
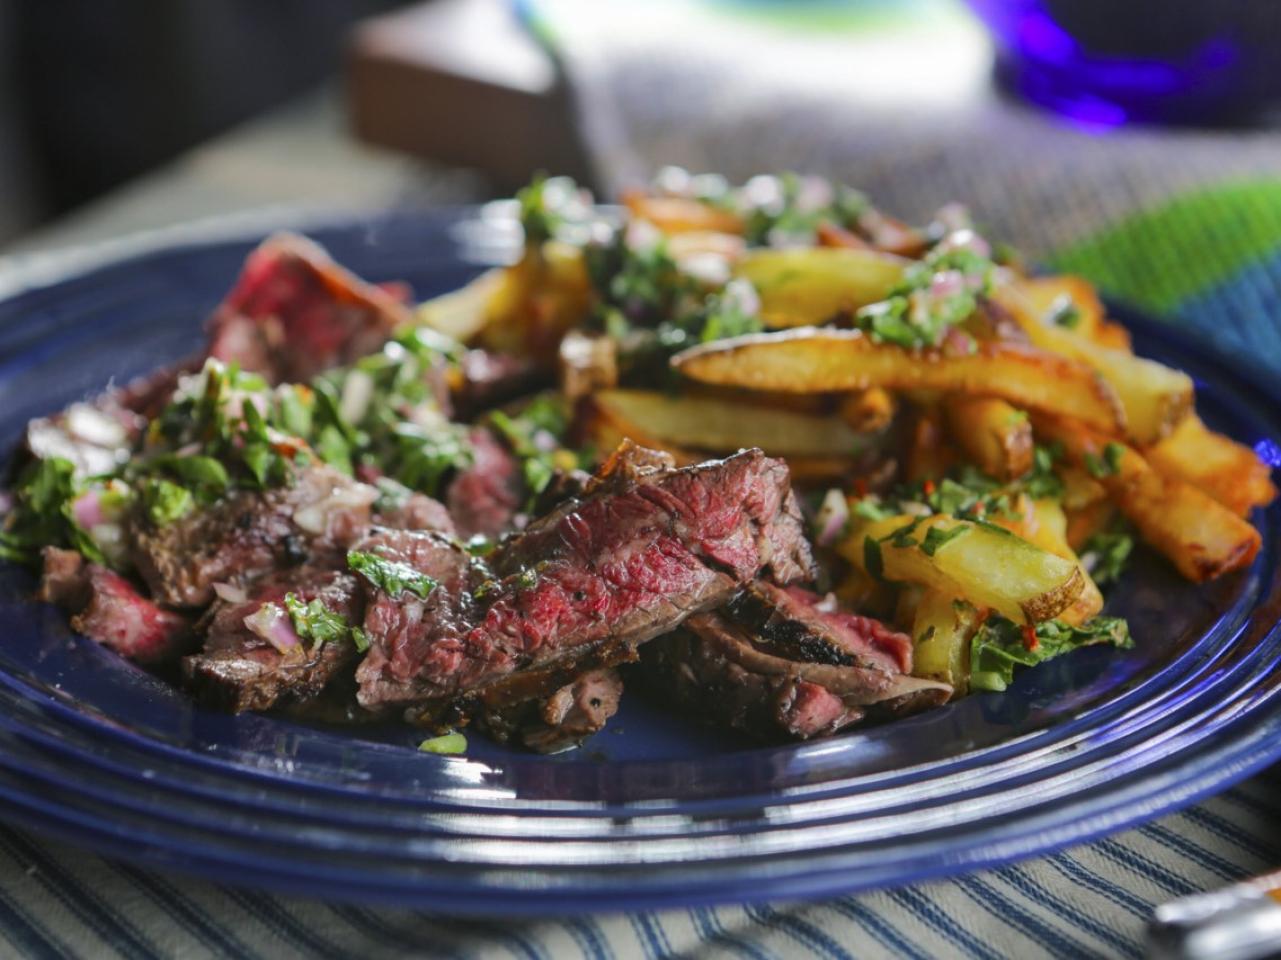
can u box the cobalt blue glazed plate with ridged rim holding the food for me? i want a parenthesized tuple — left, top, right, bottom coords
(0, 211, 1281, 914)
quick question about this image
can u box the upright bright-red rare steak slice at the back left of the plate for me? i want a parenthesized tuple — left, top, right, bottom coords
(209, 233, 412, 383)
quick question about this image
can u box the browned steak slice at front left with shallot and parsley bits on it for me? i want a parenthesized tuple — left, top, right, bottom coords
(182, 567, 364, 713)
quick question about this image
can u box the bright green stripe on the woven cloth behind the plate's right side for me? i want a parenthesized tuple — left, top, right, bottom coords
(1049, 181, 1281, 313)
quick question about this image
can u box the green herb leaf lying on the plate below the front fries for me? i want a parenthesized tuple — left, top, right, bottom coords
(970, 617, 1134, 691)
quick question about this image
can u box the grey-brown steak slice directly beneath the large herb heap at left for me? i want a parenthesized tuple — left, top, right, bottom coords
(133, 465, 378, 606)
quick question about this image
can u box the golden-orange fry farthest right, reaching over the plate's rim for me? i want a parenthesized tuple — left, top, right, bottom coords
(1143, 414, 1277, 517)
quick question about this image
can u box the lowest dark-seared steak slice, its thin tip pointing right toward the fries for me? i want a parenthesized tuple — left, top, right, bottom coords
(641, 613, 952, 741)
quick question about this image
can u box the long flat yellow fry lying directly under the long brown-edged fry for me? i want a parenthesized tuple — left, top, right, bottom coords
(591, 390, 870, 458)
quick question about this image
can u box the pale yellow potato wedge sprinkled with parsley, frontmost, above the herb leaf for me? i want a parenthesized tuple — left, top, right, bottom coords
(839, 515, 1085, 623)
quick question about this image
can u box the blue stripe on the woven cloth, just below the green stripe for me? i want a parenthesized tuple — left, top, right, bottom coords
(1175, 254, 1281, 365)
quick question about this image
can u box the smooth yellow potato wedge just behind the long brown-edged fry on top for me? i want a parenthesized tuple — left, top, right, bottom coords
(734, 247, 910, 328)
